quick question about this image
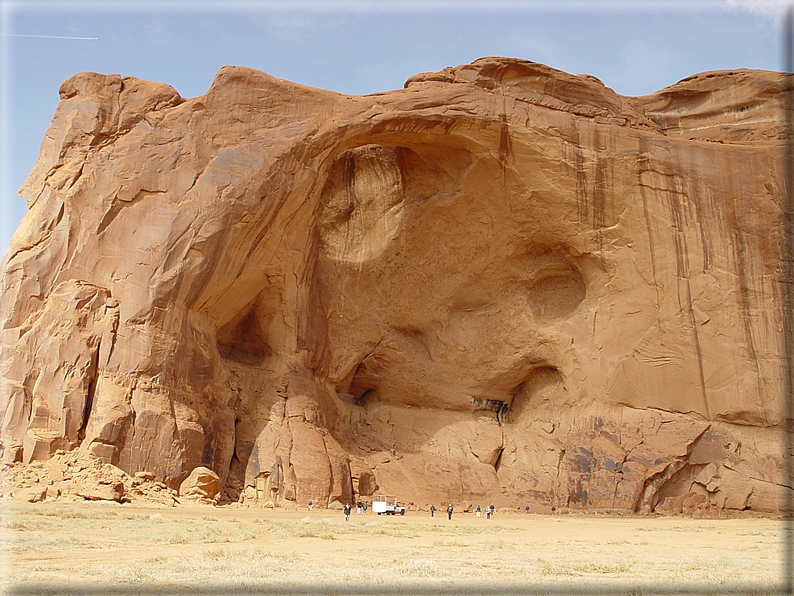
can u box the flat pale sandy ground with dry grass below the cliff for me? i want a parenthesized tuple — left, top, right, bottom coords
(0, 502, 784, 595)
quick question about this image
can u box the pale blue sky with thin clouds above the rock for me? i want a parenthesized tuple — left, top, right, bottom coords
(0, 0, 784, 252)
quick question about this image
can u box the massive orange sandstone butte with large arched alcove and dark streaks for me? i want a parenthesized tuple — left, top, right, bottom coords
(0, 58, 787, 512)
